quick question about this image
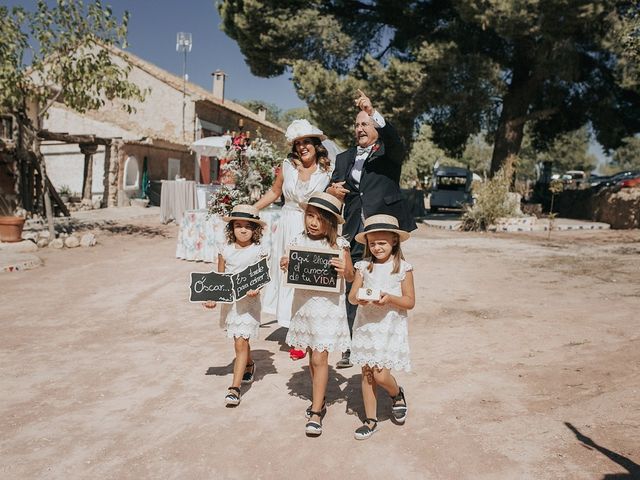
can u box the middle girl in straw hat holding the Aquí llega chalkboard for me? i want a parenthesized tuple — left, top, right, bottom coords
(280, 192, 354, 436)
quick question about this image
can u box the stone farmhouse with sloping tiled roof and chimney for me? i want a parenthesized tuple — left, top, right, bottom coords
(41, 45, 284, 206)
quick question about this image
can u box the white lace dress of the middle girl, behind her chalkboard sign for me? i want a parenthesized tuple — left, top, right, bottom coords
(287, 234, 351, 352)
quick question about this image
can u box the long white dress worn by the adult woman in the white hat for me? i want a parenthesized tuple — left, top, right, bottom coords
(262, 159, 331, 327)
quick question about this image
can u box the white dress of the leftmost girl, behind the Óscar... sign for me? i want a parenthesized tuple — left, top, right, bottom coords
(220, 243, 268, 339)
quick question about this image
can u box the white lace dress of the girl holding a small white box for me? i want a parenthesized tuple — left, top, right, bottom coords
(351, 260, 413, 372)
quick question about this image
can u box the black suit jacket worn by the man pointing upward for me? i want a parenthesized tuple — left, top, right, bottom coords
(331, 122, 417, 243)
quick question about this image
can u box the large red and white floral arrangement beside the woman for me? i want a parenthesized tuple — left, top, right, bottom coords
(207, 132, 282, 216)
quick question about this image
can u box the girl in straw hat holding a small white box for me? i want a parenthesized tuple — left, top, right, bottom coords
(349, 215, 415, 440)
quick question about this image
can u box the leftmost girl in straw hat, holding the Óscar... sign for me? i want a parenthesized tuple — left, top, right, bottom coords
(204, 205, 268, 406)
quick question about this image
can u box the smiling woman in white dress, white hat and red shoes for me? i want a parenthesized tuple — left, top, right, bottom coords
(254, 120, 331, 359)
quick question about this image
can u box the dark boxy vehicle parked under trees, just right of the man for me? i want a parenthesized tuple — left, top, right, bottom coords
(429, 166, 473, 212)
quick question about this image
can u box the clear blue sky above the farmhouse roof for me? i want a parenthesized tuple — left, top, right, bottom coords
(8, 0, 305, 110)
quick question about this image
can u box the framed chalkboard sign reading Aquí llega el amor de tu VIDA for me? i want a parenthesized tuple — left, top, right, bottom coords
(285, 247, 341, 293)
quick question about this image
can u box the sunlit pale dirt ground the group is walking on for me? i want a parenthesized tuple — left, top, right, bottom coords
(0, 220, 640, 479)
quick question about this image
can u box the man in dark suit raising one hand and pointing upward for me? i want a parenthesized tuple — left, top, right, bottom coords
(327, 90, 417, 368)
